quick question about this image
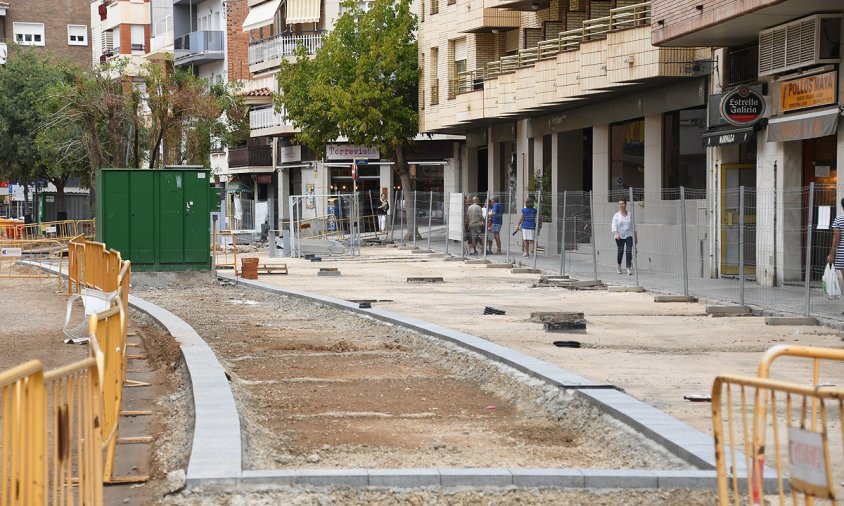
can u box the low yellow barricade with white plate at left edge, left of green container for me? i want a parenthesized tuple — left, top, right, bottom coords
(0, 239, 64, 289)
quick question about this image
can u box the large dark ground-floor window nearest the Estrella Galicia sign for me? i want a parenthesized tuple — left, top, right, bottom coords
(662, 107, 706, 200)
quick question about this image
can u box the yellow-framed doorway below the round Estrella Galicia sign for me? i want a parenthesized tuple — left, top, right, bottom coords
(721, 163, 756, 277)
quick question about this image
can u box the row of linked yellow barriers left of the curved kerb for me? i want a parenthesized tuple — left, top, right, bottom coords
(0, 235, 134, 506)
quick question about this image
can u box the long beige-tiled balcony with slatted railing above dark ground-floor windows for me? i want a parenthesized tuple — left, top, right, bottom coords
(421, 2, 711, 132)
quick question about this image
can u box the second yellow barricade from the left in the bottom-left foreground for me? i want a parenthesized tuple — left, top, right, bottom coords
(44, 358, 103, 505)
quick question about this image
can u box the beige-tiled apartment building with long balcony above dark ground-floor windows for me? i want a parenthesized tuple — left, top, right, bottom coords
(419, 0, 712, 270)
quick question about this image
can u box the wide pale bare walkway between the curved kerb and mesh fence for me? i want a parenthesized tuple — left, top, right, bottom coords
(236, 247, 844, 433)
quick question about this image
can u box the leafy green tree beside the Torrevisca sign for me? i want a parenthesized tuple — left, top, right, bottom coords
(275, 0, 419, 234)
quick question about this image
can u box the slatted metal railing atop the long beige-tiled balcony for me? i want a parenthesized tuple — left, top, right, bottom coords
(448, 2, 651, 96)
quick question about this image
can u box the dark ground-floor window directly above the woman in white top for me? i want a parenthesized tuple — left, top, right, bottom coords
(609, 118, 648, 202)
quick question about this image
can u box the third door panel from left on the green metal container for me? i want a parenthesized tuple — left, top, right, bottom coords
(158, 171, 185, 264)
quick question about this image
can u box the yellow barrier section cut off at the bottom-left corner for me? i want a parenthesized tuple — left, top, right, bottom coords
(0, 360, 47, 506)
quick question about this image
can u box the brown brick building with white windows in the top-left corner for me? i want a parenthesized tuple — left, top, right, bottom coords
(0, 0, 91, 68)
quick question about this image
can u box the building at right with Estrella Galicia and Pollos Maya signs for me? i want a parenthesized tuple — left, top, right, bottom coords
(651, 0, 844, 286)
